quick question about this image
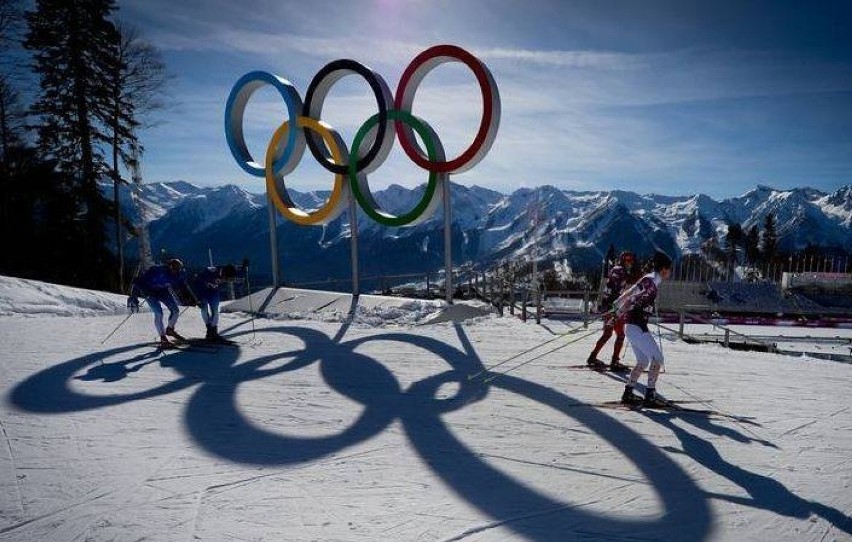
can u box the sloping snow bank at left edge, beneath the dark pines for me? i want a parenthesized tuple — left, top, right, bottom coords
(0, 276, 127, 316)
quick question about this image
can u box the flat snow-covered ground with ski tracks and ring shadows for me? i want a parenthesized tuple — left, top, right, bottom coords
(0, 278, 852, 542)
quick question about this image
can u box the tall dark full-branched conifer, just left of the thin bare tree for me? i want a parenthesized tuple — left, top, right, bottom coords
(24, 0, 118, 286)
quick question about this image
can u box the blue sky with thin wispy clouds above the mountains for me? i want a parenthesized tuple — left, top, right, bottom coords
(118, 0, 852, 197)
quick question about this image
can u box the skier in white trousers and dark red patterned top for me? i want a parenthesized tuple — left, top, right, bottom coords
(616, 252, 672, 406)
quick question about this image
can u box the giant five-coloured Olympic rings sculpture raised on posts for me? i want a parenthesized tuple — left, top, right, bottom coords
(225, 45, 500, 227)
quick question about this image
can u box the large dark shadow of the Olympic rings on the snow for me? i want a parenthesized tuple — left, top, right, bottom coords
(10, 326, 712, 540)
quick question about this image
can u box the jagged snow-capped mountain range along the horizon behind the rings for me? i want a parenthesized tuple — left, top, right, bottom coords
(113, 181, 852, 282)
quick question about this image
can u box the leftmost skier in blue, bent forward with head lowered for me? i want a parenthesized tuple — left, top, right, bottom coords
(127, 258, 191, 348)
